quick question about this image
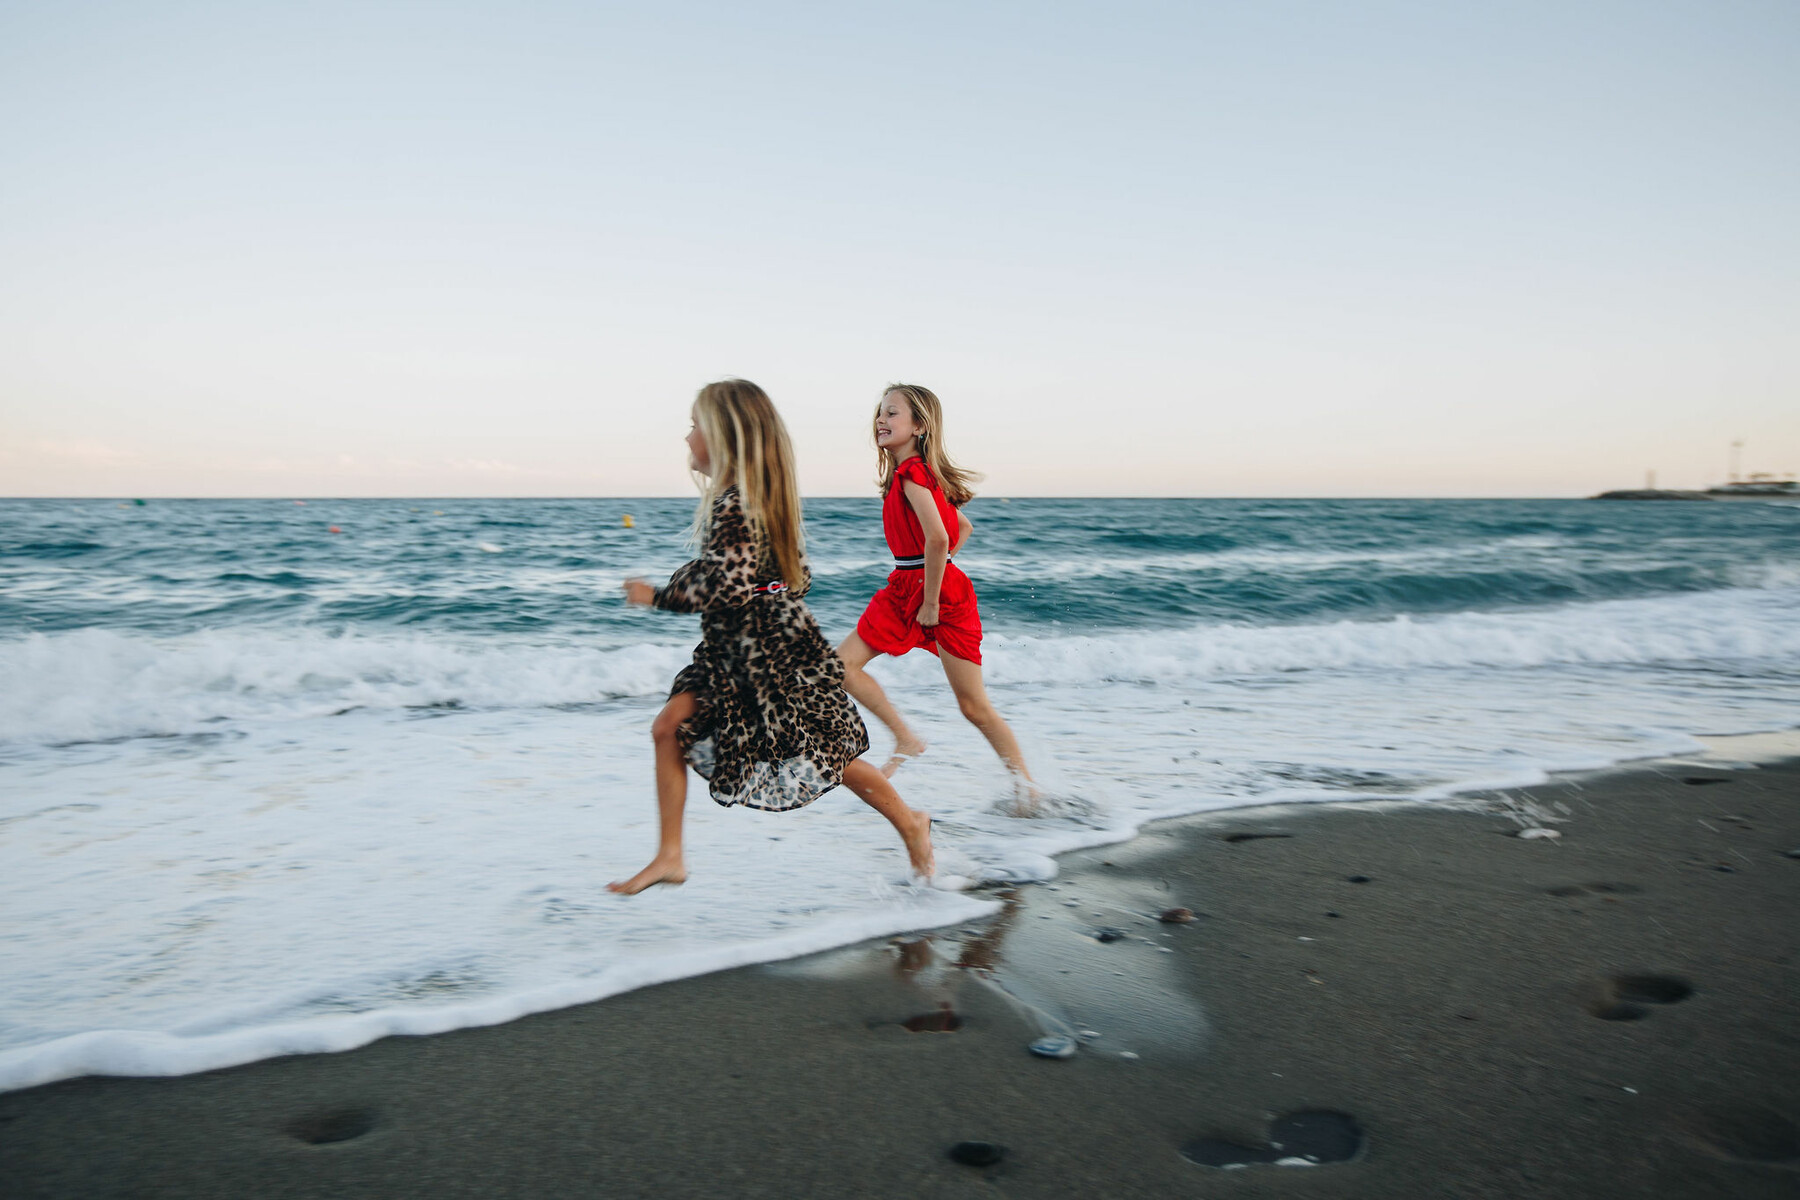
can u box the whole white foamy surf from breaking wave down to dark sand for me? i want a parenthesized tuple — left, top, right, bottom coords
(0, 588, 1800, 1088)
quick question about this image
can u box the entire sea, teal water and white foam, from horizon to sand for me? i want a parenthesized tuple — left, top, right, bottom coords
(0, 497, 1800, 1088)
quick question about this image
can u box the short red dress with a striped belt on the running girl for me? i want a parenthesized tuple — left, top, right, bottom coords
(857, 455, 981, 664)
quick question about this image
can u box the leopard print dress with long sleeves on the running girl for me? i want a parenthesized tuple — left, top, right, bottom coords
(653, 488, 869, 811)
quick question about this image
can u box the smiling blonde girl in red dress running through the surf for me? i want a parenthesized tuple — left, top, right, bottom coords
(837, 383, 1037, 801)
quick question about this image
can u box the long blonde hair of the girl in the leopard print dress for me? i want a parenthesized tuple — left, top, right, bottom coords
(693, 380, 808, 596)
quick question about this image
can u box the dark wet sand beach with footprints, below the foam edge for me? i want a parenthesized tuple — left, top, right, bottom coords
(0, 744, 1800, 1200)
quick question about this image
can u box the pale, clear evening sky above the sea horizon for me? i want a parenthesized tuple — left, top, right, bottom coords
(0, 0, 1800, 497)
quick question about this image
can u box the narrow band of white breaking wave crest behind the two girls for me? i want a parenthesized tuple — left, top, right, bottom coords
(0, 588, 1800, 743)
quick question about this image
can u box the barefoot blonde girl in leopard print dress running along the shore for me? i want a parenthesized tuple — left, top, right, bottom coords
(608, 380, 932, 894)
